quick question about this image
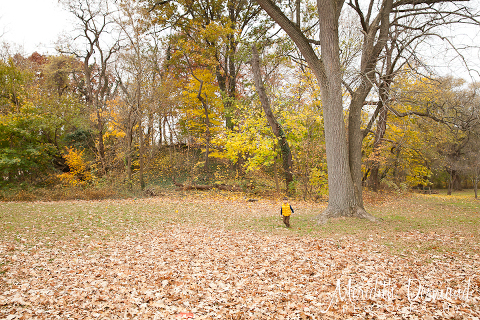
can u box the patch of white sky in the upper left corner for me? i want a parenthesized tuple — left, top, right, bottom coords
(0, 0, 72, 55)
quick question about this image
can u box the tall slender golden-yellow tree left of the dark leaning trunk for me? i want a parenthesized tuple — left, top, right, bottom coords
(158, 23, 229, 171)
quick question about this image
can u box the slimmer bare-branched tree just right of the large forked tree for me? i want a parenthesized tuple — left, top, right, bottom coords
(354, 4, 476, 191)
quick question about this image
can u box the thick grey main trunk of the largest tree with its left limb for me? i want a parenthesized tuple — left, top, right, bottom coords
(257, 0, 375, 223)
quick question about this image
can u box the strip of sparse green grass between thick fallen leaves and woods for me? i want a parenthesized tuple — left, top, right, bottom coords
(0, 191, 480, 255)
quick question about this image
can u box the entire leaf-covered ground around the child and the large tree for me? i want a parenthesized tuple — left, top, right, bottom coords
(0, 191, 480, 319)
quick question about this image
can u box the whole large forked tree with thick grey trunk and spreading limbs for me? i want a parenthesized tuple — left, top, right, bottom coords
(256, 0, 478, 221)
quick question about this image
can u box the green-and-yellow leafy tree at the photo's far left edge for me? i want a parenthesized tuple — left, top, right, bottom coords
(0, 55, 55, 184)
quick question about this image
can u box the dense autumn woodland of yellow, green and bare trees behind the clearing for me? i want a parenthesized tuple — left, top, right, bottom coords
(0, 0, 480, 206)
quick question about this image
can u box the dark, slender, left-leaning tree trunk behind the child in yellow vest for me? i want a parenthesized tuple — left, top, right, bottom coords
(252, 45, 293, 193)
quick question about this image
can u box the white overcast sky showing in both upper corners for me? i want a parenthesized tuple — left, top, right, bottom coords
(0, 0, 480, 81)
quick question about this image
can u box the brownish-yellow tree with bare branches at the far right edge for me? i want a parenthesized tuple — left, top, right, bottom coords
(386, 77, 480, 194)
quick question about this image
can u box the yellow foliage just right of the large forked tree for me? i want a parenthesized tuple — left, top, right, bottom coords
(364, 72, 460, 187)
